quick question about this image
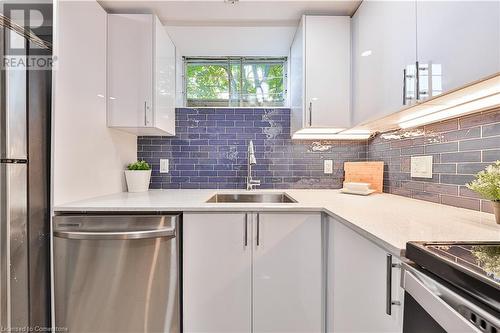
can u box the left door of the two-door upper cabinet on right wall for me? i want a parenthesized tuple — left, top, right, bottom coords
(352, 1, 417, 125)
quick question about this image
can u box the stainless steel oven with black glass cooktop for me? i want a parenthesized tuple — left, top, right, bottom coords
(401, 243, 500, 333)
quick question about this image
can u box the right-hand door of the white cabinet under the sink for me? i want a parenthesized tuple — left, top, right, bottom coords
(253, 213, 324, 333)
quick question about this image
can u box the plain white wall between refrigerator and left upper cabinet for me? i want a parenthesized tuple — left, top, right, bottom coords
(53, 1, 137, 205)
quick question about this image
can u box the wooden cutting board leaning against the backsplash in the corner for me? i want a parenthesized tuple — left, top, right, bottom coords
(344, 162, 384, 193)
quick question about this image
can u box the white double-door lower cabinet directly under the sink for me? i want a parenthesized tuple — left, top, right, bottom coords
(183, 212, 324, 333)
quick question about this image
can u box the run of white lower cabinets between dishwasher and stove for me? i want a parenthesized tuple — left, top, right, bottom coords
(183, 212, 404, 333)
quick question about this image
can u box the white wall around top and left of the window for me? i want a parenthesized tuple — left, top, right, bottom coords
(165, 25, 297, 106)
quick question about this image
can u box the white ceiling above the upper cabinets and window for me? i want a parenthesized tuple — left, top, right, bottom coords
(99, 0, 361, 26)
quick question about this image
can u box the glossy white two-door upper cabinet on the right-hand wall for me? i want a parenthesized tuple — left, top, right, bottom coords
(352, 0, 500, 126)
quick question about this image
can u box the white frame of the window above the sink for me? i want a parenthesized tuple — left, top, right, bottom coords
(182, 56, 288, 108)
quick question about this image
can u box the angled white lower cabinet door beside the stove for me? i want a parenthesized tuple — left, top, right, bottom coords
(327, 218, 404, 333)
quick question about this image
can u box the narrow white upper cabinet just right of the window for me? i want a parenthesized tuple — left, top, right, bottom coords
(290, 15, 351, 133)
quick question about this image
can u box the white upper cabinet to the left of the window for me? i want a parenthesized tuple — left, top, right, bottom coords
(107, 14, 175, 135)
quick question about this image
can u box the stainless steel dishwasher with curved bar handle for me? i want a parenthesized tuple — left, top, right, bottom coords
(53, 215, 180, 333)
